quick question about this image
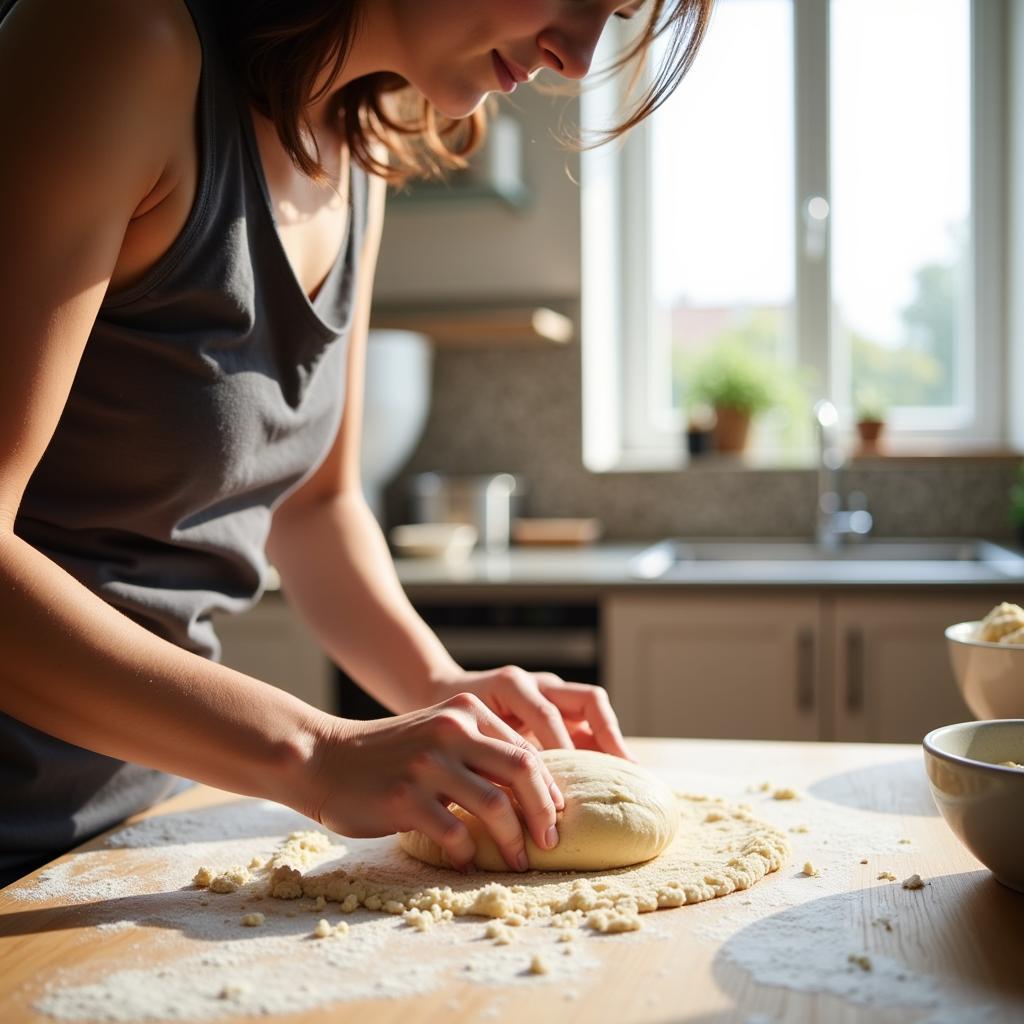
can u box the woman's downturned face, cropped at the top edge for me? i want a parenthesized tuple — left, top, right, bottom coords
(380, 0, 643, 118)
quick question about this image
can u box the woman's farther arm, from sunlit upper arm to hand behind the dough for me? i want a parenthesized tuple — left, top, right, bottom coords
(267, 169, 632, 758)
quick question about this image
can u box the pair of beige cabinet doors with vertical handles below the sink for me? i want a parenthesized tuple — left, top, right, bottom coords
(603, 588, 1021, 742)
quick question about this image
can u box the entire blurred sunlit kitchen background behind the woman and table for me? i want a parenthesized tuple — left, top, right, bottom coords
(222, 0, 1024, 741)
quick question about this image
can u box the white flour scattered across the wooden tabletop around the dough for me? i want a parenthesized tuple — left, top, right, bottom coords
(11, 766, 1005, 1024)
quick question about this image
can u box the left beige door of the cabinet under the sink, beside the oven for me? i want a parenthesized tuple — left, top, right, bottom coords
(603, 591, 821, 739)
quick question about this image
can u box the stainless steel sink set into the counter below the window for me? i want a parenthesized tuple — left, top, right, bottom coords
(630, 538, 1024, 580)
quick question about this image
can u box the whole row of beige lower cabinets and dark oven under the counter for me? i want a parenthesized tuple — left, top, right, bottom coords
(217, 587, 1024, 742)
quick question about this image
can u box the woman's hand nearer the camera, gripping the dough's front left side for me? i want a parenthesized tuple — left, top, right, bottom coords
(311, 692, 565, 870)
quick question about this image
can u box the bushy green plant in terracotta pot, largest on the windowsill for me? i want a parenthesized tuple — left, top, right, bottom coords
(689, 343, 778, 453)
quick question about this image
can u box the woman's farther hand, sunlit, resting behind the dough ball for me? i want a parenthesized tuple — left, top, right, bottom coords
(423, 665, 636, 761)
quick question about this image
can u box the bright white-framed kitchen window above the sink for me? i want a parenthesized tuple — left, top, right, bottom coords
(581, 0, 1008, 470)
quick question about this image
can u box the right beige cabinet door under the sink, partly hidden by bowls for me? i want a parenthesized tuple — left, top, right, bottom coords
(827, 592, 1020, 743)
